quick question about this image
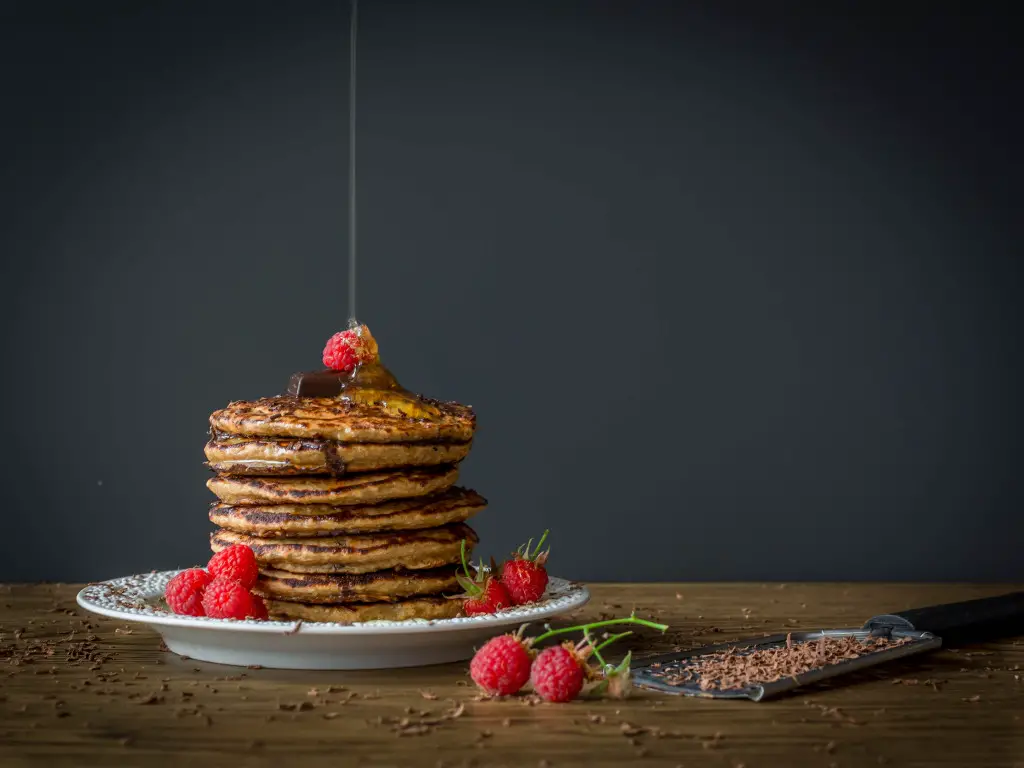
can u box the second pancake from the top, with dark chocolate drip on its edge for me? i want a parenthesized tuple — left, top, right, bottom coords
(206, 433, 472, 475)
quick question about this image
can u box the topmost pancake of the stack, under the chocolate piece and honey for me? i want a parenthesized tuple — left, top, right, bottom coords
(210, 395, 476, 442)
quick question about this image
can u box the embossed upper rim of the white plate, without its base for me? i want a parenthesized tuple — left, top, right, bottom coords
(76, 568, 590, 635)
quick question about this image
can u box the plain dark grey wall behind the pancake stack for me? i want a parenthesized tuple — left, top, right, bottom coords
(0, 0, 1024, 580)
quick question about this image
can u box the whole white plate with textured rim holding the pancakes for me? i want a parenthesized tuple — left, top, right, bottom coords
(78, 570, 590, 670)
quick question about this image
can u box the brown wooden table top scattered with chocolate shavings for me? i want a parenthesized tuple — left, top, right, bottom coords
(0, 584, 1024, 768)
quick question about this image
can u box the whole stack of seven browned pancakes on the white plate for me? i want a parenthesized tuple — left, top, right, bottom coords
(206, 395, 486, 622)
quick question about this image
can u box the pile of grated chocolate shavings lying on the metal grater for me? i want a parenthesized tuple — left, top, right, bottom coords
(659, 634, 910, 690)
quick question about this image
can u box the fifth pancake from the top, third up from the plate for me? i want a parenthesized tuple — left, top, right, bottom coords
(210, 522, 478, 573)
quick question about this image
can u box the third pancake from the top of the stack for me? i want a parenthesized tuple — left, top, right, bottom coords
(206, 467, 459, 505)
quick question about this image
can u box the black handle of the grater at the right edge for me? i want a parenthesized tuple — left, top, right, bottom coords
(864, 592, 1024, 645)
